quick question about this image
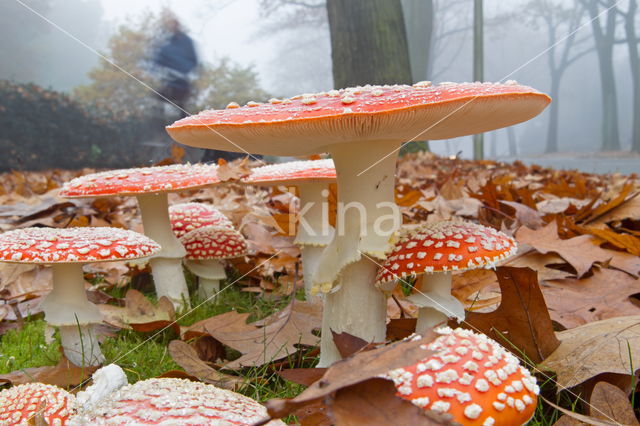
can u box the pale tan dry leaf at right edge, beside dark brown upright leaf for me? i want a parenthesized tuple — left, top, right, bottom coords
(541, 315, 640, 389)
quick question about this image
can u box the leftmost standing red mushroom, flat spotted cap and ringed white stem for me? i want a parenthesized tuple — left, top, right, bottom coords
(0, 227, 160, 366)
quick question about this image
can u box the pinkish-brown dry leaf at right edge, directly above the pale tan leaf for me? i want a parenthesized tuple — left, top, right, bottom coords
(542, 268, 640, 328)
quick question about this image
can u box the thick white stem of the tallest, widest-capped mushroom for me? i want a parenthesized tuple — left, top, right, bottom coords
(313, 141, 401, 366)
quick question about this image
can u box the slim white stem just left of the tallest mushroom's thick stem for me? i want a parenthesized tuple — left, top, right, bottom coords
(294, 182, 334, 300)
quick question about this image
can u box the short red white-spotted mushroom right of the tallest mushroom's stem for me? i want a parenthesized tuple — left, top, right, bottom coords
(377, 221, 518, 333)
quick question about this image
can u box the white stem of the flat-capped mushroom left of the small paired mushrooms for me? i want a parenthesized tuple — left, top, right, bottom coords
(137, 193, 189, 308)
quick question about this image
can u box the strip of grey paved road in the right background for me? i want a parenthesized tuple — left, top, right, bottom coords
(500, 157, 640, 175)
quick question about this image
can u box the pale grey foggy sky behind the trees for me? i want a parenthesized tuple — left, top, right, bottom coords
(0, 0, 640, 161)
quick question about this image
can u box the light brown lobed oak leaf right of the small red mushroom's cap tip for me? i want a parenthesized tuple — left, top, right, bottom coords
(516, 222, 640, 277)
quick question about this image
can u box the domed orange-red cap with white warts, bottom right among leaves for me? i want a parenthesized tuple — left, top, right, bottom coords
(388, 327, 540, 426)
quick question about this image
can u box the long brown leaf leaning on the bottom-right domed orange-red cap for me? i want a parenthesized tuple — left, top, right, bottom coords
(265, 332, 435, 418)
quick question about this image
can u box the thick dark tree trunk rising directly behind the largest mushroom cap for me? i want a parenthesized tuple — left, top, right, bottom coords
(327, 0, 412, 88)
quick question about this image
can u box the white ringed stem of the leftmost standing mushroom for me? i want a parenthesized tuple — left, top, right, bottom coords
(40, 263, 104, 367)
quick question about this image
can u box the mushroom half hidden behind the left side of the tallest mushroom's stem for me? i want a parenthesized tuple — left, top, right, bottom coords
(242, 159, 336, 300)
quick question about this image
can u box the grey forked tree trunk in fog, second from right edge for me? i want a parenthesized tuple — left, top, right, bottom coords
(586, 0, 620, 151)
